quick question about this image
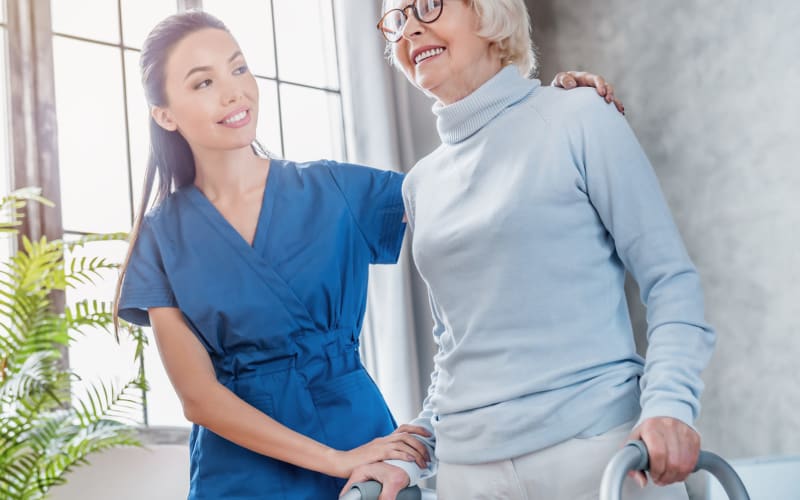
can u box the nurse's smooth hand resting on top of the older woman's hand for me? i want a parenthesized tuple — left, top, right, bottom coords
(336, 425, 430, 477)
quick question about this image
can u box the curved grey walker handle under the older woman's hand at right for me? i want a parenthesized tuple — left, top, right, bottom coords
(600, 441, 750, 500)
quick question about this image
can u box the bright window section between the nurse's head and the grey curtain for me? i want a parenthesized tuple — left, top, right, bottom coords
(202, 0, 345, 160)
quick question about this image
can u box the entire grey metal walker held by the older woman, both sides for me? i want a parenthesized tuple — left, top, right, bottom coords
(340, 441, 750, 500)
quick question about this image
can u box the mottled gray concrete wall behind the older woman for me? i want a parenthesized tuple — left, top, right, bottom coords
(530, 0, 800, 464)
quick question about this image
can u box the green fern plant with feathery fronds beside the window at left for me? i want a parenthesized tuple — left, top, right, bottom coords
(0, 188, 146, 500)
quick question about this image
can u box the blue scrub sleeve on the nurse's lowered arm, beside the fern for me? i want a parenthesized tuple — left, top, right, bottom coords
(119, 217, 177, 326)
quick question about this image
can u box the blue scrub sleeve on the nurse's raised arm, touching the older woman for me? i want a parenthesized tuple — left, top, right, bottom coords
(327, 162, 406, 264)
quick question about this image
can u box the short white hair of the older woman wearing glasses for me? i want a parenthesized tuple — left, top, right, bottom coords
(383, 0, 539, 76)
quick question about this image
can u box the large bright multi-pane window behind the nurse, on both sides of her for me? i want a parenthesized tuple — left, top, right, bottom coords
(44, 0, 345, 426)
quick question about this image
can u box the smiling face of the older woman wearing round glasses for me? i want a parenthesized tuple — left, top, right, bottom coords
(387, 0, 501, 103)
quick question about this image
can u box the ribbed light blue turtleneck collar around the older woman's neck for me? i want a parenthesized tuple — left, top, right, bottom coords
(433, 65, 540, 144)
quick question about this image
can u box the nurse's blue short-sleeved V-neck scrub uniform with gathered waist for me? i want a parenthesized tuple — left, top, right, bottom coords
(120, 159, 405, 500)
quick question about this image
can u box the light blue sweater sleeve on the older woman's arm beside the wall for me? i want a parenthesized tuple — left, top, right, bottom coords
(567, 90, 715, 426)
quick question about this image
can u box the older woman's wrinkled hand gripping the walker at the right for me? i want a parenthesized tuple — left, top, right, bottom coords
(628, 417, 700, 488)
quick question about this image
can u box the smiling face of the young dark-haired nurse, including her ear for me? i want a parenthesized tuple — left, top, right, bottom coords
(153, 28, 258, 150)
